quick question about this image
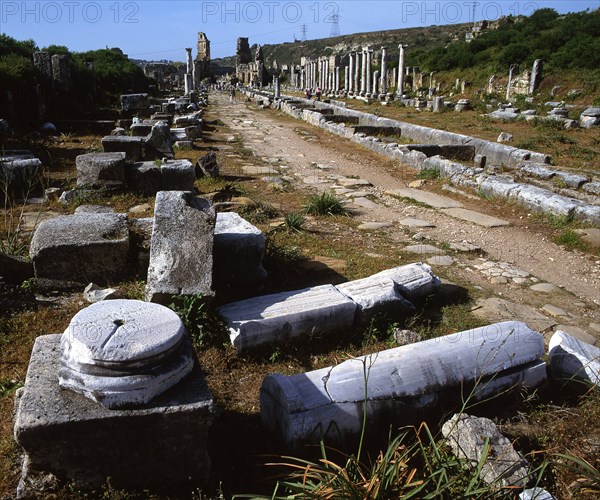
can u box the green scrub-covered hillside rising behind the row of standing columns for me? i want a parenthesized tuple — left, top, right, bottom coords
(213, 8, 600, 94)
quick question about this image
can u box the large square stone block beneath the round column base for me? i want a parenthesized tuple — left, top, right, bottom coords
(14, 334, 216, 498)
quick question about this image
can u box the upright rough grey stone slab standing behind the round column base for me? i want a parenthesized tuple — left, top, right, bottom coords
(146, 191, 215, 303)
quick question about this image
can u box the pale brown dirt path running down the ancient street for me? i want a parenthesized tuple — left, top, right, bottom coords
(211, 93, 600, 336)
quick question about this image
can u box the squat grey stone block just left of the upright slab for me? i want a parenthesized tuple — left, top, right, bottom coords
(29, 213, 129, 284)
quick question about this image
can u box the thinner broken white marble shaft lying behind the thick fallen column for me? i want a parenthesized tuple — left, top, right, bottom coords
(219, 263, 440, 352)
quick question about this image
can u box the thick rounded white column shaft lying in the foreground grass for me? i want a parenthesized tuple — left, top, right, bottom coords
(260, 319, 546, 448)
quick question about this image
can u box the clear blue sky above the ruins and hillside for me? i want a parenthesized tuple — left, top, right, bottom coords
(0, 0, 600, 61)
